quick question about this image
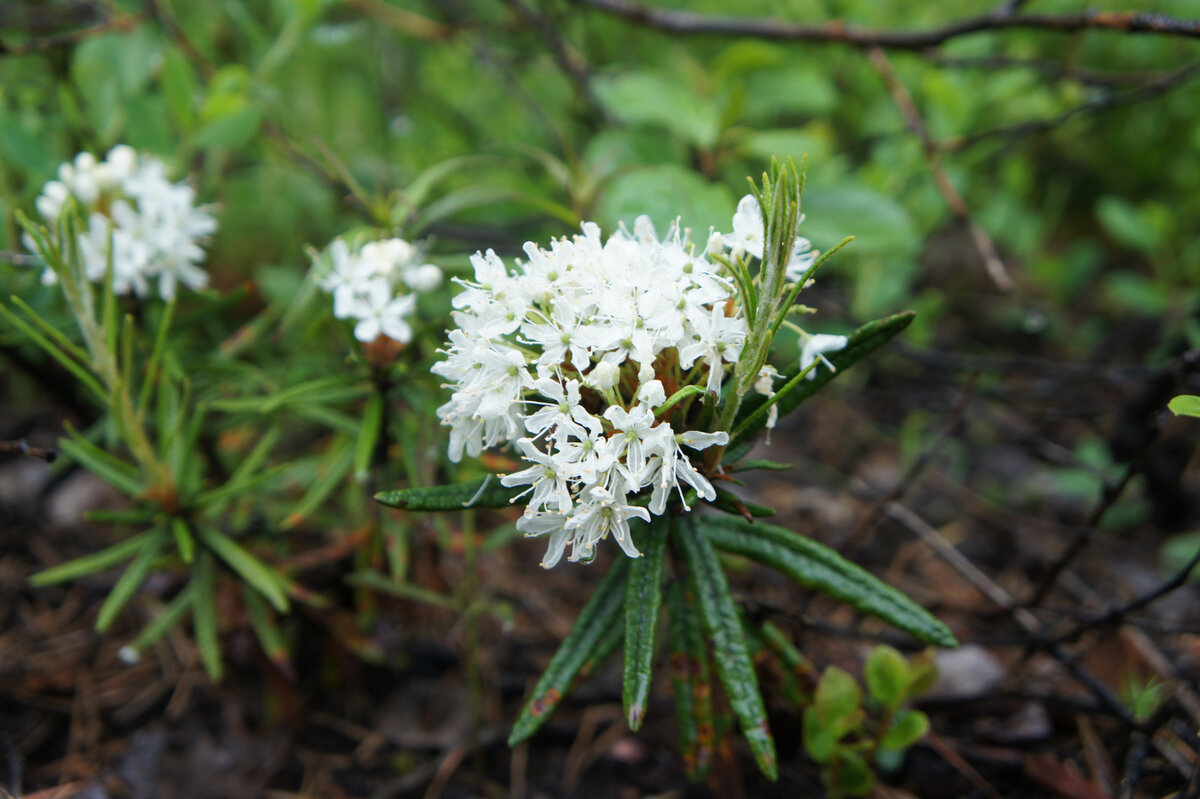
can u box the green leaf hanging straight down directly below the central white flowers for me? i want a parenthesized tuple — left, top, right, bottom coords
(622, 516, 671, 732)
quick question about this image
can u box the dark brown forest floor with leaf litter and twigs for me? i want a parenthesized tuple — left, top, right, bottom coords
(7, 245, 1200, 799)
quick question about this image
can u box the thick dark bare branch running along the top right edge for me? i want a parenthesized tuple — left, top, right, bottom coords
(575, 0, 1200, 50)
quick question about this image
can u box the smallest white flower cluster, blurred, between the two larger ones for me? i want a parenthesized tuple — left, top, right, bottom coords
(317, 233, 442, 344)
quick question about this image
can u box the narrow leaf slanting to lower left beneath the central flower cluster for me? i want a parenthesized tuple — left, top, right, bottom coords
(509, 558, 629, 746)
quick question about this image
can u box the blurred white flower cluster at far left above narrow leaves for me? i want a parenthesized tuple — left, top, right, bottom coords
(25, 145, 217, 299)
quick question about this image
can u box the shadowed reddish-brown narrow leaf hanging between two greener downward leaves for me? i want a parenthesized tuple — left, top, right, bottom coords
(667, 581, 716, 782)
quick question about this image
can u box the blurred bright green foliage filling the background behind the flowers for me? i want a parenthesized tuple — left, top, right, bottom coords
(0, 0, 1200, 781)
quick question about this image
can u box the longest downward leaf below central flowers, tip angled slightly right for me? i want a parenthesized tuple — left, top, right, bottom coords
(676, 516, 779, 780)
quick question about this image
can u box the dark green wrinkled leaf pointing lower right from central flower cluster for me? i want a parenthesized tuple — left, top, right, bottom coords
(701, 516, 958, 647)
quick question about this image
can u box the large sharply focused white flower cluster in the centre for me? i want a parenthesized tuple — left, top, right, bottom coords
(433, 217, 746, 569)
